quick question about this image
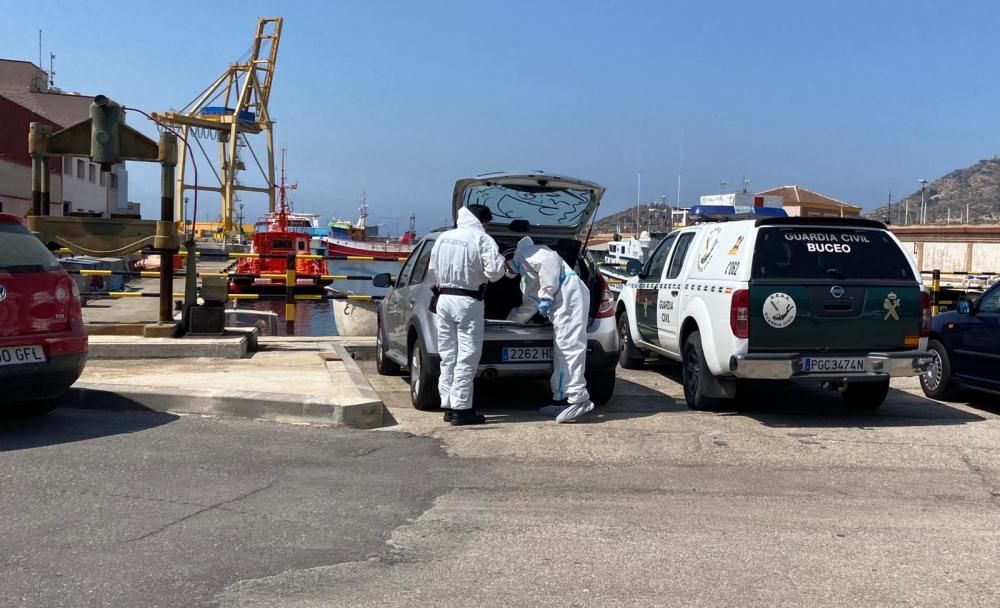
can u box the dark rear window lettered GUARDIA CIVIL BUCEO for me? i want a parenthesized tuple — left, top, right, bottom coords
(751, 226, 915, 281)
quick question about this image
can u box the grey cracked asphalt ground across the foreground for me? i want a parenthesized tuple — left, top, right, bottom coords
(0, 363, 1000, 608)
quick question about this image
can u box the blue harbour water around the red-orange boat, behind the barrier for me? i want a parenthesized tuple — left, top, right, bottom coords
(239, 260, 402, 336)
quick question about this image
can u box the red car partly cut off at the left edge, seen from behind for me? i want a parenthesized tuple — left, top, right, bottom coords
(0, 213, 87, 414)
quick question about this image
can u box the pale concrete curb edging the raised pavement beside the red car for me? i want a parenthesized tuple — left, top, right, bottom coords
(60, 376, 383, 429)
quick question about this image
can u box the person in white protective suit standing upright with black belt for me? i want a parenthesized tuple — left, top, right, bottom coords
(430, 205, 505, 426)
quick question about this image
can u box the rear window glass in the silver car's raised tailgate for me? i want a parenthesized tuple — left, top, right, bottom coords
(462, 184, 593, 228)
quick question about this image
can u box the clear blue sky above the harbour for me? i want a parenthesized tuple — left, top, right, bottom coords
(0, 0, 1000, 232)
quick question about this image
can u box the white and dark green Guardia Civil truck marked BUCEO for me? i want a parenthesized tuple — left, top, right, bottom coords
(616, 206, 932, 409)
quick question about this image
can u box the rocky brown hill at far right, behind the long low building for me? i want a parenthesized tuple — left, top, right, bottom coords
(865, 157, 1000, 224)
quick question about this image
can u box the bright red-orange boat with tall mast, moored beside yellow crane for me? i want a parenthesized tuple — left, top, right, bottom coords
(229, 150, 330, 293)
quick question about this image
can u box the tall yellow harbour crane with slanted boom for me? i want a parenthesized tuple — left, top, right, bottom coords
(153, 17, 284, 235)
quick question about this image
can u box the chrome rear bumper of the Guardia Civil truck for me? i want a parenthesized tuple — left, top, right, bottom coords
(729, 350, 931, 380)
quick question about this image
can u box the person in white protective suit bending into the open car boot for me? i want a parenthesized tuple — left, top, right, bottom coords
(507, 236, 594, 422)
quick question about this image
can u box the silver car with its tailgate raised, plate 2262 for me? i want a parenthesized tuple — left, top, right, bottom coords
(374, 172, 618, 410)
